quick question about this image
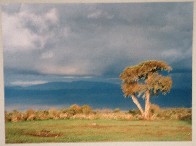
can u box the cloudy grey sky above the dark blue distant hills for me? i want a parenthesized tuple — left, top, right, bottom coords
(2, 2, 193, 88)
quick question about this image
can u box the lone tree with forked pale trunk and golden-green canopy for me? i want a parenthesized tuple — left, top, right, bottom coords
(120, 60, 172, 119)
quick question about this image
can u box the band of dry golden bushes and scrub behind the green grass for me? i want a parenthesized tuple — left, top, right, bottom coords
(5, 104, 192, 122)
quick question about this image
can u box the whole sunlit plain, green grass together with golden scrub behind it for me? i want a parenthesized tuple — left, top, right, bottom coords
(5, 105, 192, 143)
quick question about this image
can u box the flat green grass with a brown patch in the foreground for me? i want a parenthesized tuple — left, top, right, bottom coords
(5, 119, 192, 143)
